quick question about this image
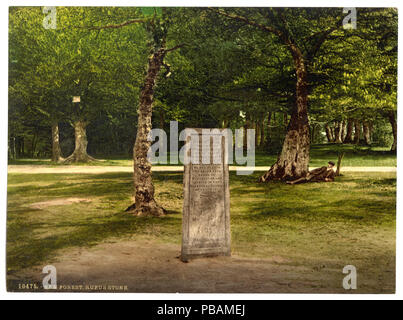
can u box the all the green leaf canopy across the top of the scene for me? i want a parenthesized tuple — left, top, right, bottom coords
(9, 7, 397, 156)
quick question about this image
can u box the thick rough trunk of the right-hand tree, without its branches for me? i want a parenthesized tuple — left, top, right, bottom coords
(260, 52, 310, 182)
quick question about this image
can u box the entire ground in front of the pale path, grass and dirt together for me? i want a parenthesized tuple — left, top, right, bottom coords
(7, 172, 396, 293)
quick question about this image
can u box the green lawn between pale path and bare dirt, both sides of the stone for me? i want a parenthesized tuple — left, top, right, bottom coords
(7, 170, 396, 289)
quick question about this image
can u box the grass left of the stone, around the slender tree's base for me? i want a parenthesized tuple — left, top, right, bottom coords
(7, 173, 182, 272)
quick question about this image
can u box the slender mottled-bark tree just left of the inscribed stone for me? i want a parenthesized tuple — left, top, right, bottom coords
(92, 8, 182, 216)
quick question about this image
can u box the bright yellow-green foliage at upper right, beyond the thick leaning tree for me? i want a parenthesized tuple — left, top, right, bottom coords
(311, 9, 397, 122)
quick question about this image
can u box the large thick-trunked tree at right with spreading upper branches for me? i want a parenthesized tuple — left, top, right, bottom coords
(210, 8, 354, 182)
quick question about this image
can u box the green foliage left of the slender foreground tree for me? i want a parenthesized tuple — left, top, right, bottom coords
(9, 7, 152, 157)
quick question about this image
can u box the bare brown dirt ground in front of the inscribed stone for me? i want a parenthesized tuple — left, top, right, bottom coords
(9, 240, 358, 293)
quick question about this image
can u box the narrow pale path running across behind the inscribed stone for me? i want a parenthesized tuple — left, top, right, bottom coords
(8, 165, 396, 174)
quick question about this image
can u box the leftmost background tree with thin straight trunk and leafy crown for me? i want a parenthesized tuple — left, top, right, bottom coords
(9, 7, 66, 163)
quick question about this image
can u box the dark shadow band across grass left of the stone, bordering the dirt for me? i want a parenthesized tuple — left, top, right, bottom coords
(7, 213, 181, 274)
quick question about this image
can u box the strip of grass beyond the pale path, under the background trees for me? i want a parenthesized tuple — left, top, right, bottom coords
(9, 144, 397, 167)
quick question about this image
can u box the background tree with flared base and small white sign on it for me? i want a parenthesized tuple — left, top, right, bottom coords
(64, 7, 145, 163)
